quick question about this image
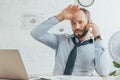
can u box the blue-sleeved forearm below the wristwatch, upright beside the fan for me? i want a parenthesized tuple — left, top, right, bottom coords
(94, 40, 110, 76)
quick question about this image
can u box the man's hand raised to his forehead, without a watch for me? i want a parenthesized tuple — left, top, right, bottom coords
(56, 4, 80, 21)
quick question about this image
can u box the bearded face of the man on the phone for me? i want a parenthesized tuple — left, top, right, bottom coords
(71, 11, 88, 39)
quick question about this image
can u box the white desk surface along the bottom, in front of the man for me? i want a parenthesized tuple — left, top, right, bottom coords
(30, 75, 120, 80)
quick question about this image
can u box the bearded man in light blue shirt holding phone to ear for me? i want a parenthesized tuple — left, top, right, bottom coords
(31, 4, 109, 76)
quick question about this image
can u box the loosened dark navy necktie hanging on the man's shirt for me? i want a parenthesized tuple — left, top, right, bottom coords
(63, 37, 93, 75)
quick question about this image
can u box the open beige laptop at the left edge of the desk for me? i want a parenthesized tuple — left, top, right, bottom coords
(0, 49, 29, 80)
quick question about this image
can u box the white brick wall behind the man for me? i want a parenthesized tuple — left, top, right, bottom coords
(0, 0, 120, 74)
